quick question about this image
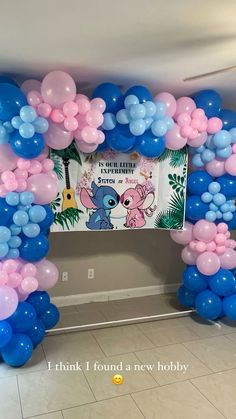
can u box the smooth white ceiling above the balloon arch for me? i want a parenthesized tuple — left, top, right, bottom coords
(0, 0, 236, 108)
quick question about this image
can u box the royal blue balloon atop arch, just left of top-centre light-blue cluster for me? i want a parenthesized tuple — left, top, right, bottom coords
(92, 83, 124, 113)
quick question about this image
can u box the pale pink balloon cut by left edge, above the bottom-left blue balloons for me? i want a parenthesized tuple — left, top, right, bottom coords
(0, 285, 18, 320)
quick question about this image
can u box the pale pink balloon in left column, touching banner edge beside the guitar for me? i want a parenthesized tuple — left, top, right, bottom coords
(27, 173, 58, 205)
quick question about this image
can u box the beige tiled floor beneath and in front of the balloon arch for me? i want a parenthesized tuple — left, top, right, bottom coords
(0, 295, 236, 419)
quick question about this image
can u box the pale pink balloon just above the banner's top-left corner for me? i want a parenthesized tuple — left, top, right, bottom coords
(44, 122, 73, 150)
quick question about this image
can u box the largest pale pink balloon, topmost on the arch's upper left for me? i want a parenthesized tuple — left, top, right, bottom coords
(41, 71, 76, 107)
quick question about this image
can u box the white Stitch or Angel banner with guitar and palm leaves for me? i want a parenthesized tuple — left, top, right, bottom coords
(51, 143, 187, 232)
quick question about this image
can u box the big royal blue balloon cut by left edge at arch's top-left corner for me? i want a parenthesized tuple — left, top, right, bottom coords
(0, 83, 27, 121)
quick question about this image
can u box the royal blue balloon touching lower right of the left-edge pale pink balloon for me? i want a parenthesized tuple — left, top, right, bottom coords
(7, 301, 36, 333)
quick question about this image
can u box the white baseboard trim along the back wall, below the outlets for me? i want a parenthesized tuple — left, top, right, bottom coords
(51, 284, 180, 307)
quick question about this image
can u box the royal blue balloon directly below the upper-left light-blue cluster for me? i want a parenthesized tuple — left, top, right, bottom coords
(9, 131, 45, 159)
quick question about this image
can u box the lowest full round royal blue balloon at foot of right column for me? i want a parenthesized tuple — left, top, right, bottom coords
(196, 290, 222, 320)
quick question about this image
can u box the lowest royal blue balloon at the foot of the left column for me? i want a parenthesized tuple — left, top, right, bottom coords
(1, 333, 33, 367)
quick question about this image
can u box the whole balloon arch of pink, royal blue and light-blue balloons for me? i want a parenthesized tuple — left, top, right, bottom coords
(0, 71, 236, 367)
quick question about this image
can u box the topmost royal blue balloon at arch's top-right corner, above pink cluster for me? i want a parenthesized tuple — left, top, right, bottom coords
(193, 89, 222, 118)
